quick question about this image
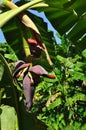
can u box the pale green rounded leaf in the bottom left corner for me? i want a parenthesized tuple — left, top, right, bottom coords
(0, 105, 18, 130)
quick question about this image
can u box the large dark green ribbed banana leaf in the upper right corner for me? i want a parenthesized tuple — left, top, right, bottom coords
(39, 0, 86, 50)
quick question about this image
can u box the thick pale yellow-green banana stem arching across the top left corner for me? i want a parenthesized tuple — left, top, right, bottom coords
(0, 0, 48, 27)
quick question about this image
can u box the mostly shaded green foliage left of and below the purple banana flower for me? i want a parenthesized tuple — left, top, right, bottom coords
(0, 43, 46, 130)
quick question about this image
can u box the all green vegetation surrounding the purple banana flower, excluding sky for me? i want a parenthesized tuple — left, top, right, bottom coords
(0, 0, 86, 130)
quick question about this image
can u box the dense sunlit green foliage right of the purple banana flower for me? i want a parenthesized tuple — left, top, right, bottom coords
(32, 35, 86, 130)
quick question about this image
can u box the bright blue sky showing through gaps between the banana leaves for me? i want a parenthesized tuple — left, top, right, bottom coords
(0, 0, 61, 43)
